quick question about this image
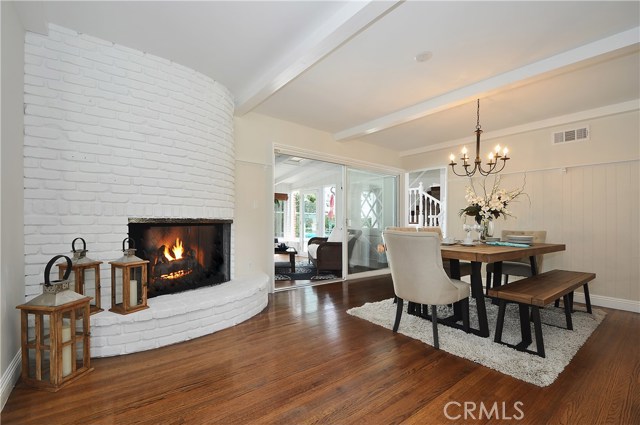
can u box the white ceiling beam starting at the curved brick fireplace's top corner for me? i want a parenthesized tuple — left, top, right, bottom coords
(235, 0, 402, 116)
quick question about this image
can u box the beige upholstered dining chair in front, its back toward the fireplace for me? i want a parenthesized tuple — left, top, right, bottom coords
(383, 228, 470, 349)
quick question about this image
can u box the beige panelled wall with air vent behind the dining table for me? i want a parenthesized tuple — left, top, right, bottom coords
(404, 111, 640, 311)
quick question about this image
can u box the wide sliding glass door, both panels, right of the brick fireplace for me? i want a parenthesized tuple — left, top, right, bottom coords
(274, 153, 398, 289)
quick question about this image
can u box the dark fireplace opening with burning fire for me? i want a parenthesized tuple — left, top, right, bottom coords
(129, 219, 231, 298)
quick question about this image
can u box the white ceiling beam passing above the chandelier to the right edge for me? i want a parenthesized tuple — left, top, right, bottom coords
(333, 27, 640, 141)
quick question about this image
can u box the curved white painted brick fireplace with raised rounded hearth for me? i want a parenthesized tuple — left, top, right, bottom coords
(24, 25, 268, 357)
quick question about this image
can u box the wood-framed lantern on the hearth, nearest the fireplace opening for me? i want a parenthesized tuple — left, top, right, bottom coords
(109, 238, 149, 314)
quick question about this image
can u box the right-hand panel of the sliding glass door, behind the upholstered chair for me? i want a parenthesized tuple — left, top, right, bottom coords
(346, 168, 398, 274)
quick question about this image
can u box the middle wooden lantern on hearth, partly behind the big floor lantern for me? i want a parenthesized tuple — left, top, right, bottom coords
(56, 238, 102, 314)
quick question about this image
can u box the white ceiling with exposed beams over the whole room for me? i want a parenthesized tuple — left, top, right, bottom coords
(15, 1, 640, 155)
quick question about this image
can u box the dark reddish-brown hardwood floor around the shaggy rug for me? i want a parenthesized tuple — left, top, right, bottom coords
(1, 277, 640, 425)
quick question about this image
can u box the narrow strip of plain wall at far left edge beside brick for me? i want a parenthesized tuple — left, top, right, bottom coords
(0, 1, 25, 407)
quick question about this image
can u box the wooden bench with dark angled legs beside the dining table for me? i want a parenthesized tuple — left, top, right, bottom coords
(489, 270, 596, 357)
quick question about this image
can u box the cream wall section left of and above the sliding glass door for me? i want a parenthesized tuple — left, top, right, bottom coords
(235, 113, 400, 284)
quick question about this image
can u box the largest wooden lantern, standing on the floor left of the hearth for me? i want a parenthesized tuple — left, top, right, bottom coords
(16, 255, 93, 391)
